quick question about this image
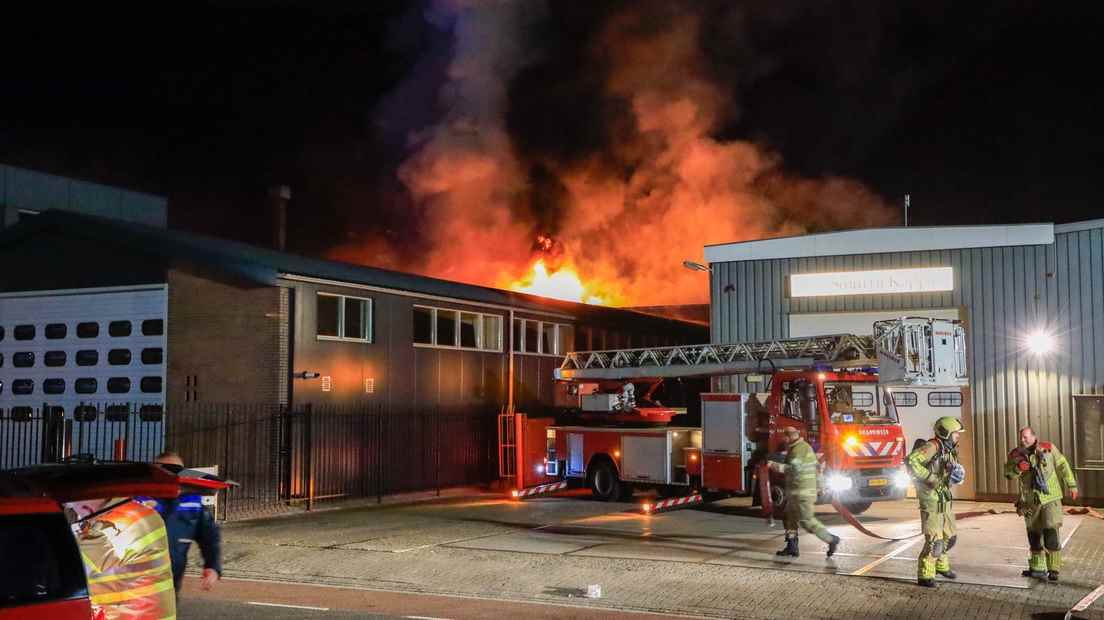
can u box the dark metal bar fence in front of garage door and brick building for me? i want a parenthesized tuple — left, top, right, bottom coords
(0, 403, 497, 519)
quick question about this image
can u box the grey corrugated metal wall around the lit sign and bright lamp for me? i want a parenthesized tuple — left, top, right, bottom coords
(711, 222, 1104, 499)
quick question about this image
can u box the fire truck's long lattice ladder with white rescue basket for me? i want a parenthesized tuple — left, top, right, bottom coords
(555, 318, 966, 386)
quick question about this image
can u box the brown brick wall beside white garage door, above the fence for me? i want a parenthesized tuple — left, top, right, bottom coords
(167, 268, 288, 403)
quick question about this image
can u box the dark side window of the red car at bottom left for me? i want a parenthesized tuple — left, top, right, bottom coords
(0, 513, 88, 609)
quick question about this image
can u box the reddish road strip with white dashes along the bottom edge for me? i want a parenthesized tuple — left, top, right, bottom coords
(177, 577, 669, 620)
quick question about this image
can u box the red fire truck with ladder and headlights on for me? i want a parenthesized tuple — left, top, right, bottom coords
(519, 318, 966, 514)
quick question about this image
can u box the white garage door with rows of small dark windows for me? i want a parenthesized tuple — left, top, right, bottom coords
(0, 286, 168, 464)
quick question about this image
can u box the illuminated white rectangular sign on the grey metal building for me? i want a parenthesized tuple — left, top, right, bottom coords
(789, 267, 955, 297)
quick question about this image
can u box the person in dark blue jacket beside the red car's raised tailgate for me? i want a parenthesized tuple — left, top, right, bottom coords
(141, 452, 222, 594)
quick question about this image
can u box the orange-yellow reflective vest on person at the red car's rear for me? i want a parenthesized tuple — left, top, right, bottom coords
(77, 499, 177, 620)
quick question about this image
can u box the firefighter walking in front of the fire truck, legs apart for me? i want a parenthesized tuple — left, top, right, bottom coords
(768, 426, 839, 557)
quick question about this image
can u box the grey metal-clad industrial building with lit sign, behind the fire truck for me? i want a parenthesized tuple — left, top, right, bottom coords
(704, 220, 1104, 502)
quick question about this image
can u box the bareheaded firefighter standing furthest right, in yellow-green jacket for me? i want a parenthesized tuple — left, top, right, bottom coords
(1005, 427, 1078, 581)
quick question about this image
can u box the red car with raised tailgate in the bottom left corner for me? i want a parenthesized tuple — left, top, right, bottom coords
(0, 462, 226, 620)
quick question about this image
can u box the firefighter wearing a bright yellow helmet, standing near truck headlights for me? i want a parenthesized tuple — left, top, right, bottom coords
(909, 416, 966, 588)
